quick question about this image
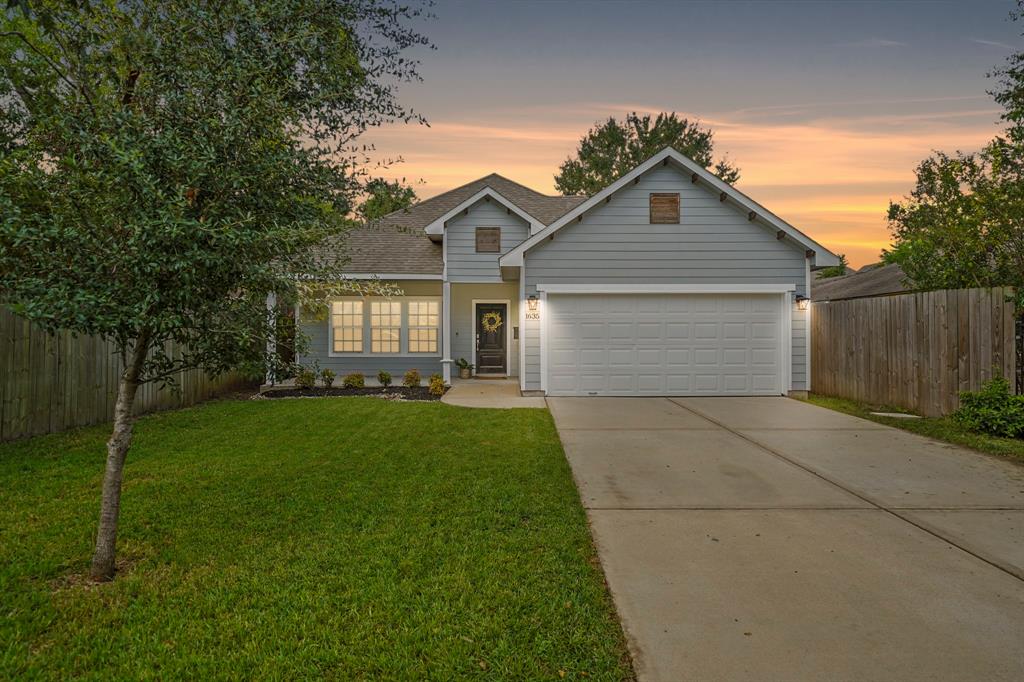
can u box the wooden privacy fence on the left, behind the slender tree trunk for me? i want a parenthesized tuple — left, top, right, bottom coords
(0, 307, 248, 441)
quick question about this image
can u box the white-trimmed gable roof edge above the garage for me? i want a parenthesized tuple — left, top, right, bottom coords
(499, 146, 839, 266)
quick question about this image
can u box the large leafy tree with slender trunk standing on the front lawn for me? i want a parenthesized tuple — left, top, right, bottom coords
(0, 0, 426, 580)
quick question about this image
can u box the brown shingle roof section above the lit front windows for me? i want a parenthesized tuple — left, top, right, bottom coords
(318, 173, 587, 274)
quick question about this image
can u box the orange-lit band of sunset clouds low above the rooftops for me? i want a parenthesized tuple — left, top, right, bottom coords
(370, 102, 998, 266)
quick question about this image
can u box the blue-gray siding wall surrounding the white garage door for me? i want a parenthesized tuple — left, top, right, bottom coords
(522, 161, 809, 390)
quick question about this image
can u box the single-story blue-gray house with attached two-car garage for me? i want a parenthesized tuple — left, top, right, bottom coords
(300, 148, 839, 395)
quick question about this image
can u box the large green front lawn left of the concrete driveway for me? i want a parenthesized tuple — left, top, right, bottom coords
(0, 398, 633, 680)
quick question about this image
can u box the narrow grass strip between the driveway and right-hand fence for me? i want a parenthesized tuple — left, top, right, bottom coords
(807, 393, 1024, 463)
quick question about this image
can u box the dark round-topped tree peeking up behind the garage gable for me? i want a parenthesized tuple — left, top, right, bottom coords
(555, 112, 739, 196)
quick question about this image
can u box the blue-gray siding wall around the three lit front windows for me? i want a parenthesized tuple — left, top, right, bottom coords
(296, 280, 444, 384)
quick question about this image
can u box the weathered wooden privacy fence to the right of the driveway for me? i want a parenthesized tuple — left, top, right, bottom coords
(811, 288, 1016, 416)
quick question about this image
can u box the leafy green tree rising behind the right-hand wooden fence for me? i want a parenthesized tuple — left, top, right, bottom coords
(883, 0, 1024, 305)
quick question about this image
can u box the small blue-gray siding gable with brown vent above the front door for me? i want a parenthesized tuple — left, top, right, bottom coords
(444, 199, 529, 280)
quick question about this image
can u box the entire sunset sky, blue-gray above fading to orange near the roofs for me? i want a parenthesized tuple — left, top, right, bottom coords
(367, 0, 1024, 267)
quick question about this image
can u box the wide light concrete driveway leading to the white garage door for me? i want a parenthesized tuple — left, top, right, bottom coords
(548, 397, 1024, 682)
